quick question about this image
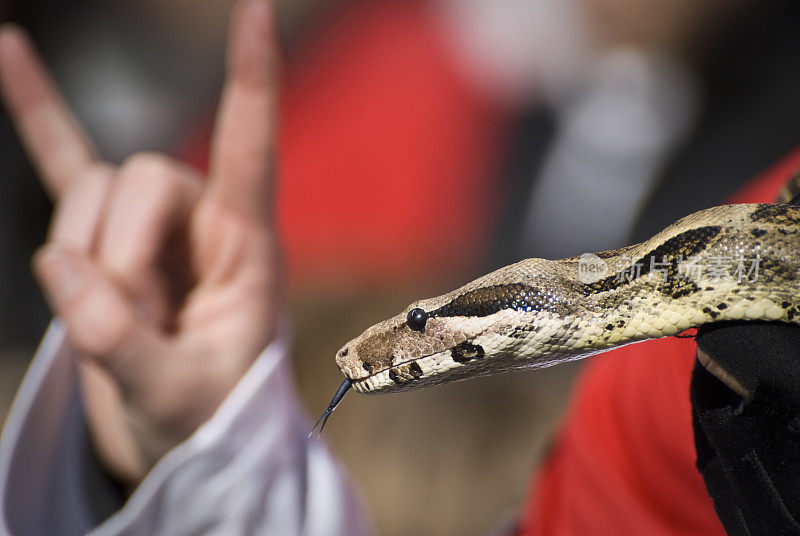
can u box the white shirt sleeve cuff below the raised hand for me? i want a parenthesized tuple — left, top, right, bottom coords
(0, 322, 370, 536)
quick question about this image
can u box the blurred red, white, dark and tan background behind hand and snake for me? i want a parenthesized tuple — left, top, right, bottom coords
(0, 0, 800, 535)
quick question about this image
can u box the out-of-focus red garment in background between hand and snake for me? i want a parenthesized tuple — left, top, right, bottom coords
(180, 1, 510, 286)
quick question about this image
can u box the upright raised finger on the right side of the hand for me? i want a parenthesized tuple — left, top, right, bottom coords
(209, 0, 275, 222)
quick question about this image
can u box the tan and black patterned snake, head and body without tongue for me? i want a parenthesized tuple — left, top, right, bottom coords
(336, 203, 800, 393)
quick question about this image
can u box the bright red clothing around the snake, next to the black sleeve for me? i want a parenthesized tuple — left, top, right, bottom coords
(521, 151, 800, 536)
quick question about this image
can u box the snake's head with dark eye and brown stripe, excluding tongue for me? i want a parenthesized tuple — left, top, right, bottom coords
(336, 259, 580, 393)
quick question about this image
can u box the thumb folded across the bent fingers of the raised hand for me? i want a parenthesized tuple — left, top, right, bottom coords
(33, 244, 164, 392)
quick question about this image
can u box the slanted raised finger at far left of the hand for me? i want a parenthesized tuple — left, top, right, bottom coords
(0, 26, 96, 197)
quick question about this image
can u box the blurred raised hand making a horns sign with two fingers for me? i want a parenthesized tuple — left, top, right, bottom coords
(0, 0, 281, 484)
